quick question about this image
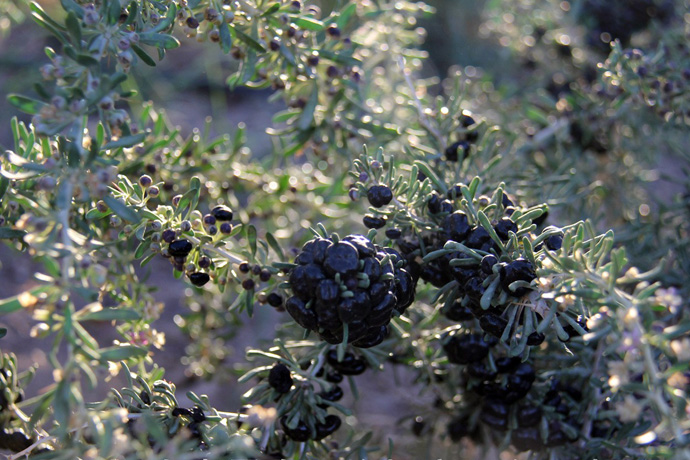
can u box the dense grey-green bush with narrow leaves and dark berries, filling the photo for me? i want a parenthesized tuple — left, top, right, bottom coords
(0, 0, 690, 459)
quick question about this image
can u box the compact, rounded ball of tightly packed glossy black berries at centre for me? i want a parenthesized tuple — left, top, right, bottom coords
(285, 235, 415, 348)
